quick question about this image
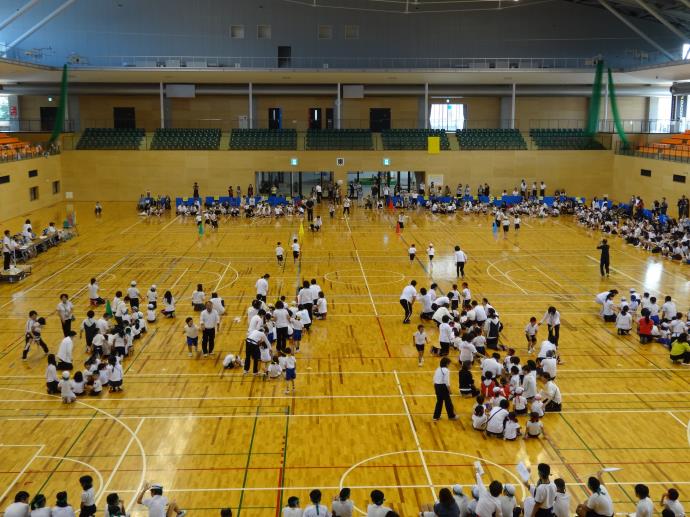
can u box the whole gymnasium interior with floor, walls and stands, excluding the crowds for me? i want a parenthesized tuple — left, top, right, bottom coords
(0, 0, 690, 517)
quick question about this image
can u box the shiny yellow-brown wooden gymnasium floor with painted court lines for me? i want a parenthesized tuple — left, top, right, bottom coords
(0, 203, 690, 516)
